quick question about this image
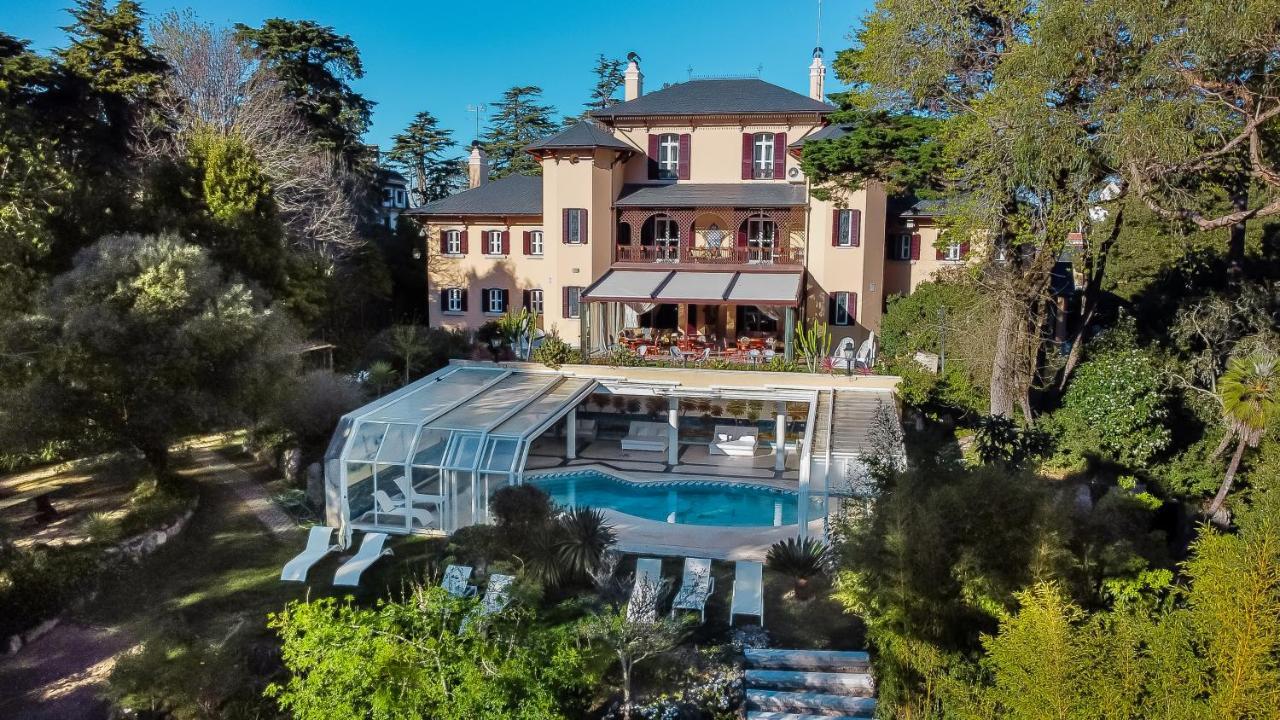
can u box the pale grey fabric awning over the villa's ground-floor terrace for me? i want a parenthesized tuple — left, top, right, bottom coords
(582, 269, 803, 306)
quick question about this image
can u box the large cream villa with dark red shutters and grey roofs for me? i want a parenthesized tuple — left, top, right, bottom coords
(403, 49, 968, 357)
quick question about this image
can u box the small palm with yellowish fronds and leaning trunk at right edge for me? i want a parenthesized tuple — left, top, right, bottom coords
(1208, 351, 1280, 518)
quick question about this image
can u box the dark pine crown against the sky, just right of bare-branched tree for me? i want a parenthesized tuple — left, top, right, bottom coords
(236, 18, 374, 156)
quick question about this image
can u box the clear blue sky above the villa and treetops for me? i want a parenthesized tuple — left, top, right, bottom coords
(0, 0, 870, 154)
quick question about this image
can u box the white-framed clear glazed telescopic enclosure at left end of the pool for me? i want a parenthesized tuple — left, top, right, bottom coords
(324, 365, 596, 539)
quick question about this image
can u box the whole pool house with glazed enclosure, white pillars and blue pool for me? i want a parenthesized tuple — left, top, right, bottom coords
(324, 361, 901, 560)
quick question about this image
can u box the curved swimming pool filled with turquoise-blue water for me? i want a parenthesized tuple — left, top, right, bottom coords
(527, 470, 820, 528)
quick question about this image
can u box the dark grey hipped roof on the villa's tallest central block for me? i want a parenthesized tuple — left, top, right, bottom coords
(591, 78, 835, 118)
